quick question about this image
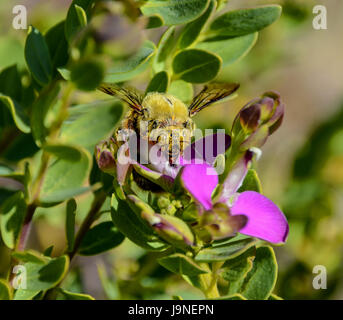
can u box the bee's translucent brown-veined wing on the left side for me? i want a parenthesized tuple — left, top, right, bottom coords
(98, 83, 143, 112)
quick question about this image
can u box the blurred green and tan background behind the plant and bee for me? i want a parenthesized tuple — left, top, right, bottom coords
(0, 0, 343, 299)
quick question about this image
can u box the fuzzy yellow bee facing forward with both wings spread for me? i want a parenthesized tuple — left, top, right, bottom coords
(99, 83, 239, 164)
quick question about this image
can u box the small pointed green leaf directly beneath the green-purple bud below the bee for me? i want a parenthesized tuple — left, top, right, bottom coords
(157, 253, 207, 276)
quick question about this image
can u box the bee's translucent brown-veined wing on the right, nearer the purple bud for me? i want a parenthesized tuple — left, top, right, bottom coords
(188, 83, 239, 116)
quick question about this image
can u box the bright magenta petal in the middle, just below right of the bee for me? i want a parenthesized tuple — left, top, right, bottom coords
(181, 163, 218, 210)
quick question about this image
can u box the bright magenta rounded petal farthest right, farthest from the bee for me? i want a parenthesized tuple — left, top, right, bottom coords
(231, 191, 289, 243)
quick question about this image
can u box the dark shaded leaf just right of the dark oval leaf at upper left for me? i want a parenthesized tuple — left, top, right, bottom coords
(44, 20, 69, 68)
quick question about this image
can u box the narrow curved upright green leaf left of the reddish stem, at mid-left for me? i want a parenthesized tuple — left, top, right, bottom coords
(30, 85, 61, 147)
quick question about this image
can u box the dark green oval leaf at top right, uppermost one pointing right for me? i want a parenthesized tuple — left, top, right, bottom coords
(210, 5, 282, 37)
